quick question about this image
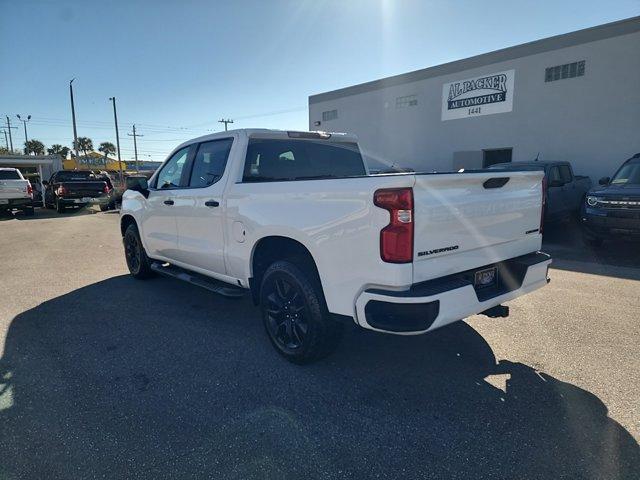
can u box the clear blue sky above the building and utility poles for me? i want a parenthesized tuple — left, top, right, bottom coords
(0, 0, 640, 161)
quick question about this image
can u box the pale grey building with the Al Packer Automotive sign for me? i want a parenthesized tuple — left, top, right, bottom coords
(309, 17, 640, 180)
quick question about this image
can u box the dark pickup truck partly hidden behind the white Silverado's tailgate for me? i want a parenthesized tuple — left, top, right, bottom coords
(489, 161, 591, 222)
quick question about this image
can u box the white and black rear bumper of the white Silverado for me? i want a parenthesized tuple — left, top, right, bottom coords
(356, 252, 551, 335)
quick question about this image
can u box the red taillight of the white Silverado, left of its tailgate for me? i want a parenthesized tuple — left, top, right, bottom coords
(373, 188, 413, 263)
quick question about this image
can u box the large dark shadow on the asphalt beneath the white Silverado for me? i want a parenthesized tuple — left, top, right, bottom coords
(0, 276, 640, 479)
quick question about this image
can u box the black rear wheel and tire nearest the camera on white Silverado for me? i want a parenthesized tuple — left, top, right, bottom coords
(260, 260, 343, 364)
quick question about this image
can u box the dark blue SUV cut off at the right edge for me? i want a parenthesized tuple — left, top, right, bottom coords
(580, 153, 640, 247)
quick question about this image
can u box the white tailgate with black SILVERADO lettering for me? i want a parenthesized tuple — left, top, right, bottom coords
(413, 171, 543, 283)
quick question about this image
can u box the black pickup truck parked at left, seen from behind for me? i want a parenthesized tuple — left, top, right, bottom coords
(42, 170, 113, 213)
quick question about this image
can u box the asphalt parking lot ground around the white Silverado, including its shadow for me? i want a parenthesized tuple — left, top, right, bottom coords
(0, 211, 640, 479)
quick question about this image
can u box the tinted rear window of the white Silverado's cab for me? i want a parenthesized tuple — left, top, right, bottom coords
(242, 139, 366, 182)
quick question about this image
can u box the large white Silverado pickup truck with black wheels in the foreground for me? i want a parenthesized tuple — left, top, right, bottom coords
(121, 129, 551, 363)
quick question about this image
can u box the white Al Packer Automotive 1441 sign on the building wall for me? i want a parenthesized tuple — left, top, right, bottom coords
(442, 70, 515, 121)
